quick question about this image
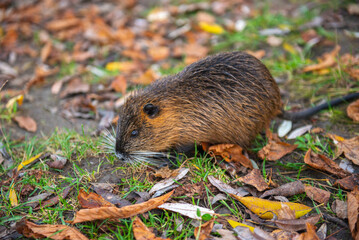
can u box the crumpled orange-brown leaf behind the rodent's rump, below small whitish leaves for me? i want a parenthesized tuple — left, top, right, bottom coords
(258, 140, 297, 161)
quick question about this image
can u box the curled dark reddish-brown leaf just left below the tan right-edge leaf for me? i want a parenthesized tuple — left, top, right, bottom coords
(304, 149, 349, 178)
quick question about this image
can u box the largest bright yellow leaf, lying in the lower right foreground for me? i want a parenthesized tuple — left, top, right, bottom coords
(231, 194, 312, 219)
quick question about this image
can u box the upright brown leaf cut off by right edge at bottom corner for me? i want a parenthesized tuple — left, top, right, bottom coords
(348, 186, 359, 239)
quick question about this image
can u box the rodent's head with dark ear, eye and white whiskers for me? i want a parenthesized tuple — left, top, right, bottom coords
(115, 92, 181, 161)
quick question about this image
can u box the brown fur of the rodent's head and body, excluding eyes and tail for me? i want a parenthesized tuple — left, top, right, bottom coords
(116, 52, 280, 157)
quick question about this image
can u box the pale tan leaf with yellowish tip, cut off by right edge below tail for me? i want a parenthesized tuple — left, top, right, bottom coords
(328, 133, 359, 165)
